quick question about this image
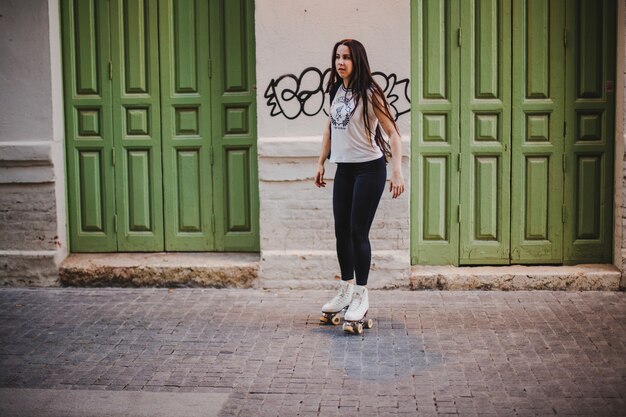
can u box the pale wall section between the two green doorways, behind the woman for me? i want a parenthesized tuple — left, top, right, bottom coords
(255, 0, 410, 287)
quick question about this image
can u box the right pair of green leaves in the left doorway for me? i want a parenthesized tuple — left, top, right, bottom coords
(160, 0, 259, 251)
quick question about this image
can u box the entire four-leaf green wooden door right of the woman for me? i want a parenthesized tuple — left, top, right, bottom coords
(411, 0, 616, 265)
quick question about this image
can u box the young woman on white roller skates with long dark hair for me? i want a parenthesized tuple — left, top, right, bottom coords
(315, 39, 404, 333)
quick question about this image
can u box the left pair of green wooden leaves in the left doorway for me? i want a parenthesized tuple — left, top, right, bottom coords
(62, 0, 163, 252)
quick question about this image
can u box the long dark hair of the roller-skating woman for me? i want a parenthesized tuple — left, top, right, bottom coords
(326, 39, 400, 160)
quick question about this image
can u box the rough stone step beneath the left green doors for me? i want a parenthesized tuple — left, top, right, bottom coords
(59, 252, 259, 288)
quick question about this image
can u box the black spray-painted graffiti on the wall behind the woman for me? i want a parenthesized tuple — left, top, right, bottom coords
(264, 67, 411, 120)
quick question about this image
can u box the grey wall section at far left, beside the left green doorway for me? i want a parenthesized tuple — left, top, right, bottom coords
(0, 0, 65, 285)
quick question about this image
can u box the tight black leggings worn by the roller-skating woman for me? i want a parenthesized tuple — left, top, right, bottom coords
(333, 157, 387, 285)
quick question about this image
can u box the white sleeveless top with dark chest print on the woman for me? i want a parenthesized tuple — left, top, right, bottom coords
(330, 84, 383, 163)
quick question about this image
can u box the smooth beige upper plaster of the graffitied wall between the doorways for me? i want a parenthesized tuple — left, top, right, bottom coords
(255, 0, 411, 138)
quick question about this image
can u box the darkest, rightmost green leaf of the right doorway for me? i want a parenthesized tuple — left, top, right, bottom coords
(563, 0, 617, 264)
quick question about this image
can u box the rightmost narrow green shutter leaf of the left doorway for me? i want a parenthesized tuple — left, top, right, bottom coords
(209, 0, 259, 251)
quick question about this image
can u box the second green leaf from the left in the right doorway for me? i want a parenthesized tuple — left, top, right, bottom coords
(459, 0, 511, 264)
